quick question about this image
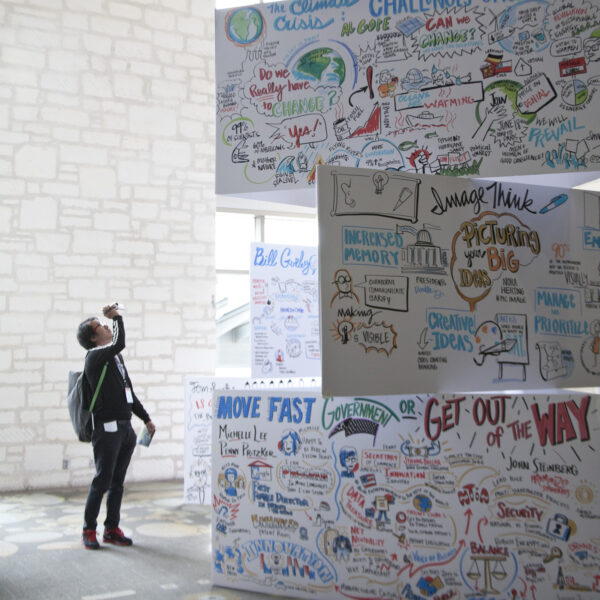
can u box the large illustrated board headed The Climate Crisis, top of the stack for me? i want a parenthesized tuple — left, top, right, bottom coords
(215, 0, 600, 198)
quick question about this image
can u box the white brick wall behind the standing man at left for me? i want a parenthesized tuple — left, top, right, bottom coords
(0, 0, 215, 491)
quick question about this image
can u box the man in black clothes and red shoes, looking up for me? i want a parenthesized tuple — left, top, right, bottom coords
(77, 304, 155, 550)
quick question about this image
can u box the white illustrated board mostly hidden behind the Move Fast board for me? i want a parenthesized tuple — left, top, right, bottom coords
(183, 375, 321, 504)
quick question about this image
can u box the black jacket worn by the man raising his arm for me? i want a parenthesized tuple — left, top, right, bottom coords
(84, 315, 150, 423)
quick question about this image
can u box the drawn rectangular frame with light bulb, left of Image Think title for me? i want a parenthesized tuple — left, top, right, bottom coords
(331, 171, 421, 223)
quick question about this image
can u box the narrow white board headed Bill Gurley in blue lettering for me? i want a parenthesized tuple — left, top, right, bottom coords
(250, 243, 321, 378)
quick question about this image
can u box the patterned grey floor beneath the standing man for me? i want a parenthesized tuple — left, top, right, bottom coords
(0, 481, 290, 600)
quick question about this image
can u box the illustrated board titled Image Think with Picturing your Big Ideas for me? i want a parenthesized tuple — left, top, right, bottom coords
(318, 166, 600, 396)
